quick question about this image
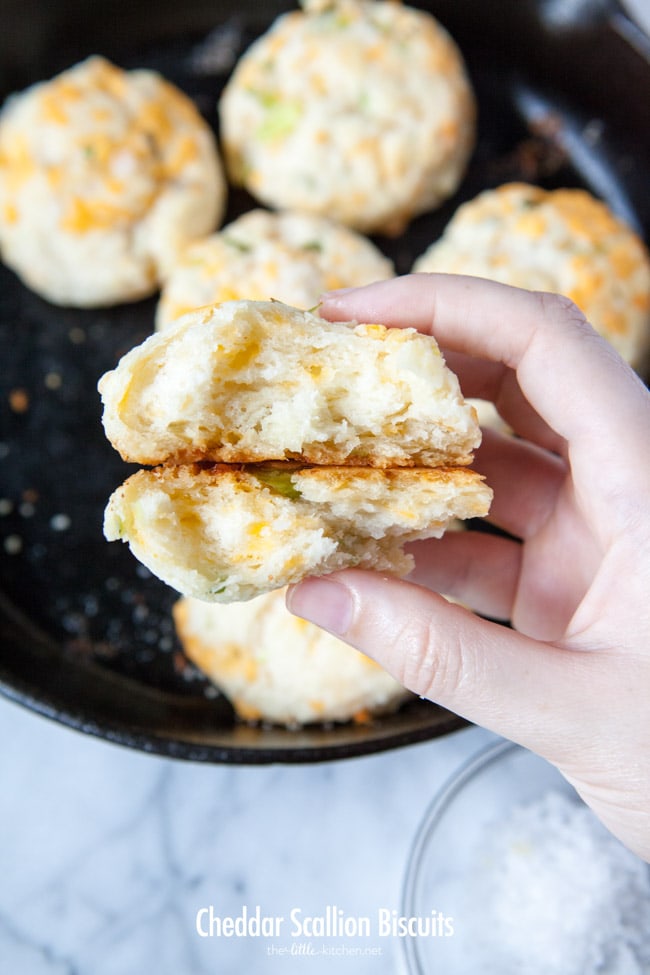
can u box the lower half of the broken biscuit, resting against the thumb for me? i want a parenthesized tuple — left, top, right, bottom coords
(104, 465, 492, 602)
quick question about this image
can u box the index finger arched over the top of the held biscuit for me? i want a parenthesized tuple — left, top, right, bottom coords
(320, 274, 650, 495)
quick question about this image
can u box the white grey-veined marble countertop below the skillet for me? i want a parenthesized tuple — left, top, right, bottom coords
(0, 698, 492, 975)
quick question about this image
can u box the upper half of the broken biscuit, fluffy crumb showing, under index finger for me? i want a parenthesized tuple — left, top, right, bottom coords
(99, 301, 480, 467)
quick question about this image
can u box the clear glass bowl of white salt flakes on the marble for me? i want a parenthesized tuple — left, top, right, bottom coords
(396, 740, 650, 975)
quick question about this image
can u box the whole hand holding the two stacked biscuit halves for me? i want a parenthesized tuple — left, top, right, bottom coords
(288, 274, 650, 859)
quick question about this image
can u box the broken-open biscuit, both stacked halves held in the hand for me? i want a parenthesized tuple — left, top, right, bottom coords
(100, 301, 491, 602)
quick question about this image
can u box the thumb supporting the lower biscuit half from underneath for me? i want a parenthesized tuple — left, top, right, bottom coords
(287, 569, 591, 762)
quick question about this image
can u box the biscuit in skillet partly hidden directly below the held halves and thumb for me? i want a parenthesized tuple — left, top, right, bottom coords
(173, 589, 409, 727)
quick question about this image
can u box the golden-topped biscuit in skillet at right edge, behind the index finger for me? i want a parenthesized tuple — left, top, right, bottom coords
(413, 183, 650, 368)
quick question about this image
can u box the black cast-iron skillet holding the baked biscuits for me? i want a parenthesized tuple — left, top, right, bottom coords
(0, 0, 650, 763)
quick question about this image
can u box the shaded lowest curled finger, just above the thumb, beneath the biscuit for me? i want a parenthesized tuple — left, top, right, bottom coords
(408, 531, 522, 620)
